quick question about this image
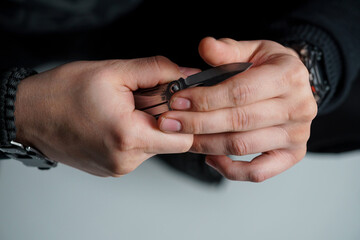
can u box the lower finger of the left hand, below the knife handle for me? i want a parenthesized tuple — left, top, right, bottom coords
(127, 110, 193, 154)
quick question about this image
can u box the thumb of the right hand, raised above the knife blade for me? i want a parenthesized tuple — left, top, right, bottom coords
(199, 37, 260, 66)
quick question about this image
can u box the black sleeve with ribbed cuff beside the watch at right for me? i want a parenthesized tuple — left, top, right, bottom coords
(270, 0, 360, 114)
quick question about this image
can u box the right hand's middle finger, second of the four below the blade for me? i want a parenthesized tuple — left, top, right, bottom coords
(158, 98, 289, 134)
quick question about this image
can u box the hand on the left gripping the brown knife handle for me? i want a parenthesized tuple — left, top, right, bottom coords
(15, 57, 193, 176)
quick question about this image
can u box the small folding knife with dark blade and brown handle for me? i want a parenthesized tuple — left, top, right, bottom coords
(134, 63, 252, 117)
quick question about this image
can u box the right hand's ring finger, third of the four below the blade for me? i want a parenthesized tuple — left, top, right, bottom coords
(190, 126, 292, 156)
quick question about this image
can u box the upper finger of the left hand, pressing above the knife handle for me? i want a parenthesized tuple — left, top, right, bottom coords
(120, 56, 194, 91)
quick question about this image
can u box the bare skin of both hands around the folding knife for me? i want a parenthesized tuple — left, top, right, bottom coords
(15, 37, 317, 182)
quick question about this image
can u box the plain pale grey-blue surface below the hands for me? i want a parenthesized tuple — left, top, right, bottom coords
(0, 152, 360, 240)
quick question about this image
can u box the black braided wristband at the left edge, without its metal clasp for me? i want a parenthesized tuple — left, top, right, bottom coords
(0, 67, 37, 146)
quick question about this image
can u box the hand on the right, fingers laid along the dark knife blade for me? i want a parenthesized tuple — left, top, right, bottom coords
(158, 38, 317, 182)
